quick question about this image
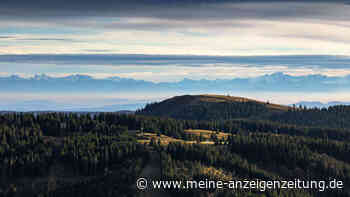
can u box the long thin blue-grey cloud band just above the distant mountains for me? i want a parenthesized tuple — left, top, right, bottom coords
(0, 53, 350, 69)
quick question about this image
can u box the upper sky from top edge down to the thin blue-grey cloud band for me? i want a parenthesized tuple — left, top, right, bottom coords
(0, 0, 350, 56)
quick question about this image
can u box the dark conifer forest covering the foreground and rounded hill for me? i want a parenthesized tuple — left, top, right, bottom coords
(0, 96, 350, 197)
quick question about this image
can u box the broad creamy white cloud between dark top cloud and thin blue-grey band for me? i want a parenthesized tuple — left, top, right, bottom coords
(0, 8, 350, 55)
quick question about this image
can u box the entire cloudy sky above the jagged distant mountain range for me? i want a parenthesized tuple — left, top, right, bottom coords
(0, 0, 350, 107)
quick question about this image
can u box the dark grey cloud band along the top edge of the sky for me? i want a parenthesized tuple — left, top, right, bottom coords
(0, 0, 350, 21)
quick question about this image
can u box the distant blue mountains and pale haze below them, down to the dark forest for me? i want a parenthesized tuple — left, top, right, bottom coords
(0, 69, 350, 111)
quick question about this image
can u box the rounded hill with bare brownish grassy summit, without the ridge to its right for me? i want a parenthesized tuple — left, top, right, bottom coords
(137, 95, 290, 120)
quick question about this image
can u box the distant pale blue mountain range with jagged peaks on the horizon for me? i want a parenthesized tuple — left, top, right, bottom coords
(0, 72, 350, 92)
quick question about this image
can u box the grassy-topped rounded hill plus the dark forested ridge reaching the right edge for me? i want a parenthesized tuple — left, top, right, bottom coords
(136, 95, 350, 129)
